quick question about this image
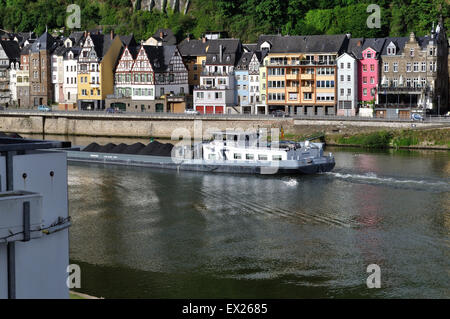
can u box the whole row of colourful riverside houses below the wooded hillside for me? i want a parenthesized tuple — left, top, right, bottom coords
(0, 23, 450, 117)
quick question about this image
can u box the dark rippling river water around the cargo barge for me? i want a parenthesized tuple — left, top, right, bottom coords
(31, 134, 450, 298)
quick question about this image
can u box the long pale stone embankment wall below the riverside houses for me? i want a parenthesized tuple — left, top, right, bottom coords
(0, 110, 450, 138)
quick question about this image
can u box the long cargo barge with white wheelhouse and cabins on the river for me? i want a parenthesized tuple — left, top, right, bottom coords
(66, 132, 335, 175)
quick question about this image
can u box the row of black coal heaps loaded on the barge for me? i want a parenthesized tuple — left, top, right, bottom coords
(83, 141, 174, 157)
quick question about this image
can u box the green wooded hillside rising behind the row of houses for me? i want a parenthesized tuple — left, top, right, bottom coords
(0, 0, 450, 42)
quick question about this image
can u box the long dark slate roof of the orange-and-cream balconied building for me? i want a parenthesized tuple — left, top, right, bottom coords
(258, 34, 347, 53)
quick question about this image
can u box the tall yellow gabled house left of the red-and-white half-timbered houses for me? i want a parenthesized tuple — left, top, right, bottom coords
(77, 34, 123, 110)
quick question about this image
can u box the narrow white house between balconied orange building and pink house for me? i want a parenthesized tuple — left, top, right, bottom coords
(336, 53, 358, 116)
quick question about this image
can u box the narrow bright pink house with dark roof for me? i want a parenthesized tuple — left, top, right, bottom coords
(358, 39, 385, 107)
